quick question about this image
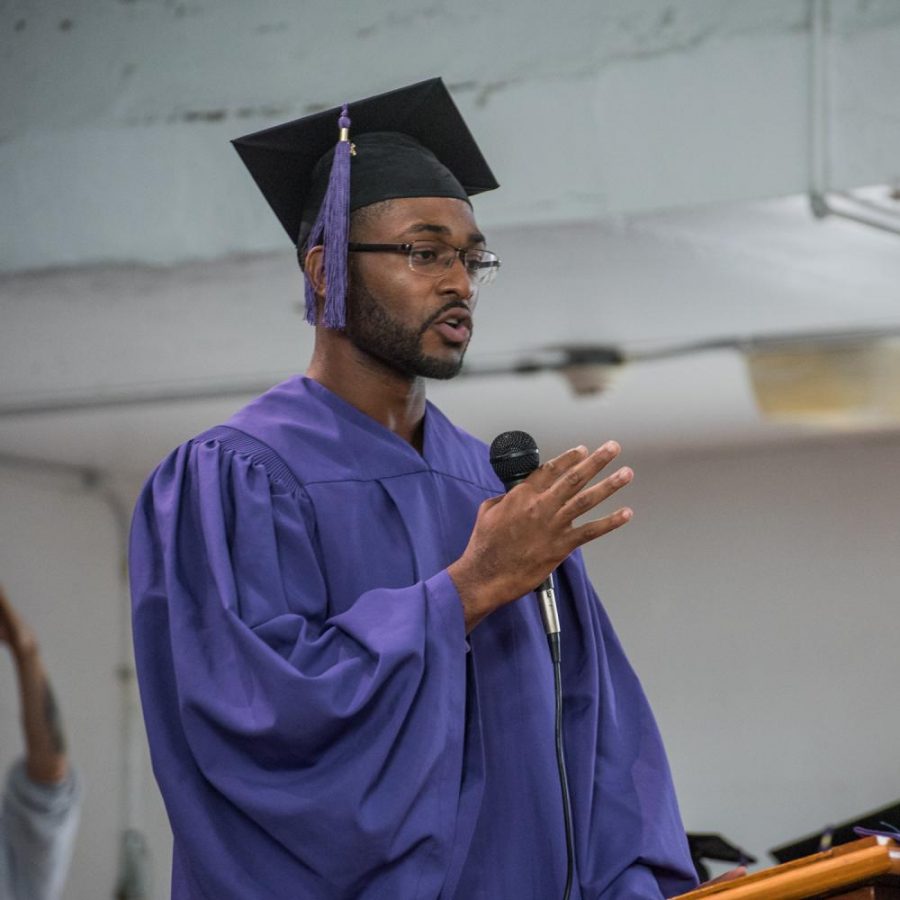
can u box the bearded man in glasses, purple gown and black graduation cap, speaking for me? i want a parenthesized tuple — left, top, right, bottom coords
(131, 79, 695, 900)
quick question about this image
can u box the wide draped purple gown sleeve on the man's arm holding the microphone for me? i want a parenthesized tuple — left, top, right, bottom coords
(131, 440, 474, 898)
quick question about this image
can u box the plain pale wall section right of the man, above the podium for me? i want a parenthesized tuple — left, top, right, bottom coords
(588, 438, 900, 863)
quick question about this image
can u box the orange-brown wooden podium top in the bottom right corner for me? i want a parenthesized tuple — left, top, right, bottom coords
(672, 837, 900, 900)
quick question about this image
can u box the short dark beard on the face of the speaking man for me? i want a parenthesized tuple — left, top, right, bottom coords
(344, 276, 465, 379)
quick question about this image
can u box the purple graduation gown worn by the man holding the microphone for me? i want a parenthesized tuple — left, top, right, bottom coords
(131, 377, 695, 900)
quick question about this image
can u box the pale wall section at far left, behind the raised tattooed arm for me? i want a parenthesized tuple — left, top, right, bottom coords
(0, 465, 171, 900)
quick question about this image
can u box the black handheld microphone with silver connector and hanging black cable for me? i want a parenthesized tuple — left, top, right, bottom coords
(490, 431, 575, 900)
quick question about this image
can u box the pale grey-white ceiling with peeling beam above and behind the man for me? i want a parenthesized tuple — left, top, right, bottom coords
(0, 0, 900, 474)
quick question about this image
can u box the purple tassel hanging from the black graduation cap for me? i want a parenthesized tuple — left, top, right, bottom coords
(305, 104, 353, 328)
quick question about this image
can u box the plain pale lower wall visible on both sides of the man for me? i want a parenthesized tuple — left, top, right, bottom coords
(0, 439, 900, 900)
